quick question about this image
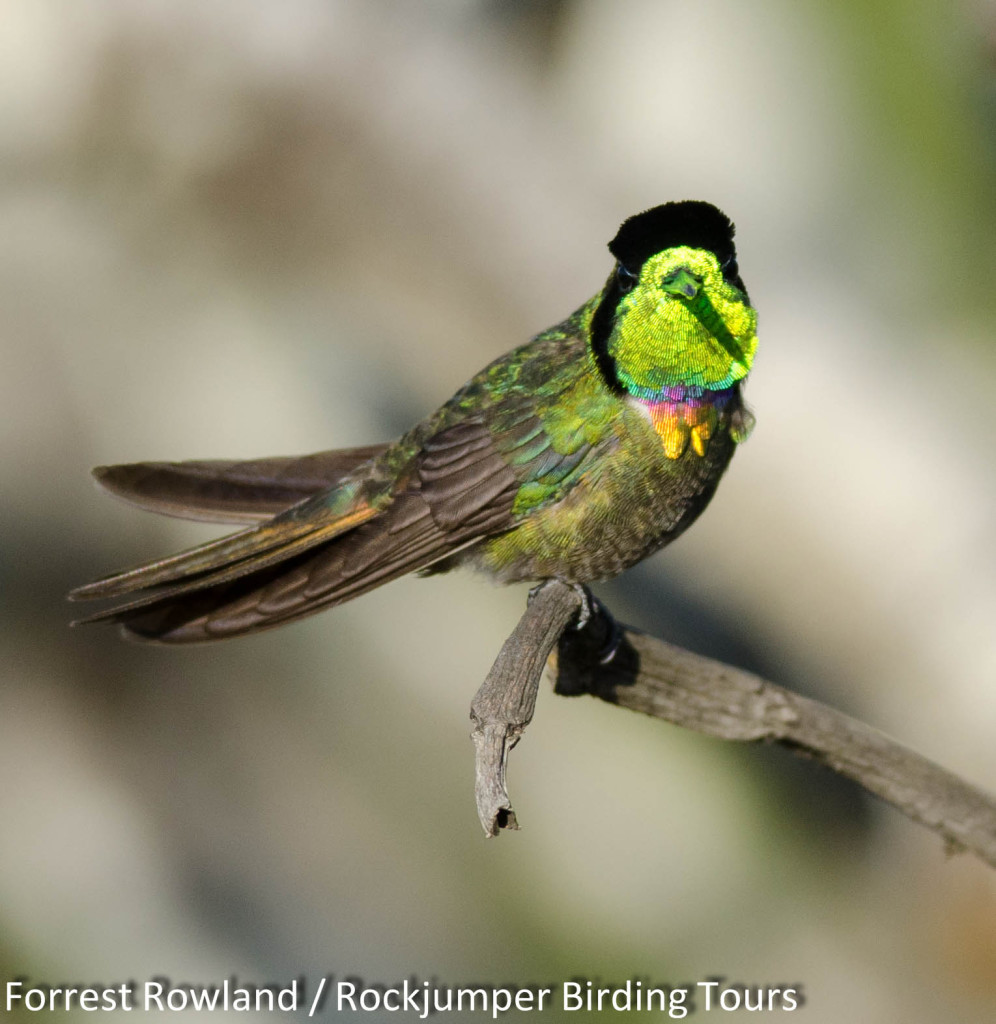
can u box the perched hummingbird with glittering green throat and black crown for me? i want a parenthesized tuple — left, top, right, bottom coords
(70, 201, 757, 643)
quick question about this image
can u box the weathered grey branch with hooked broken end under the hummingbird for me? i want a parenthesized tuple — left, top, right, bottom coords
(470, 583, 996, 867)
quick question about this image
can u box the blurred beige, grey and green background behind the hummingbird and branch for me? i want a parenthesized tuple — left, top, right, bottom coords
(0, 0, 996, 1024)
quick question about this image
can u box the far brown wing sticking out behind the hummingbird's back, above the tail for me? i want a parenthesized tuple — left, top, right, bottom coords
(93, 444, 387, 523)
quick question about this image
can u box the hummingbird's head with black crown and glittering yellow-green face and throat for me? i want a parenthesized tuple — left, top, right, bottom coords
(592, 201, 757, 398)
